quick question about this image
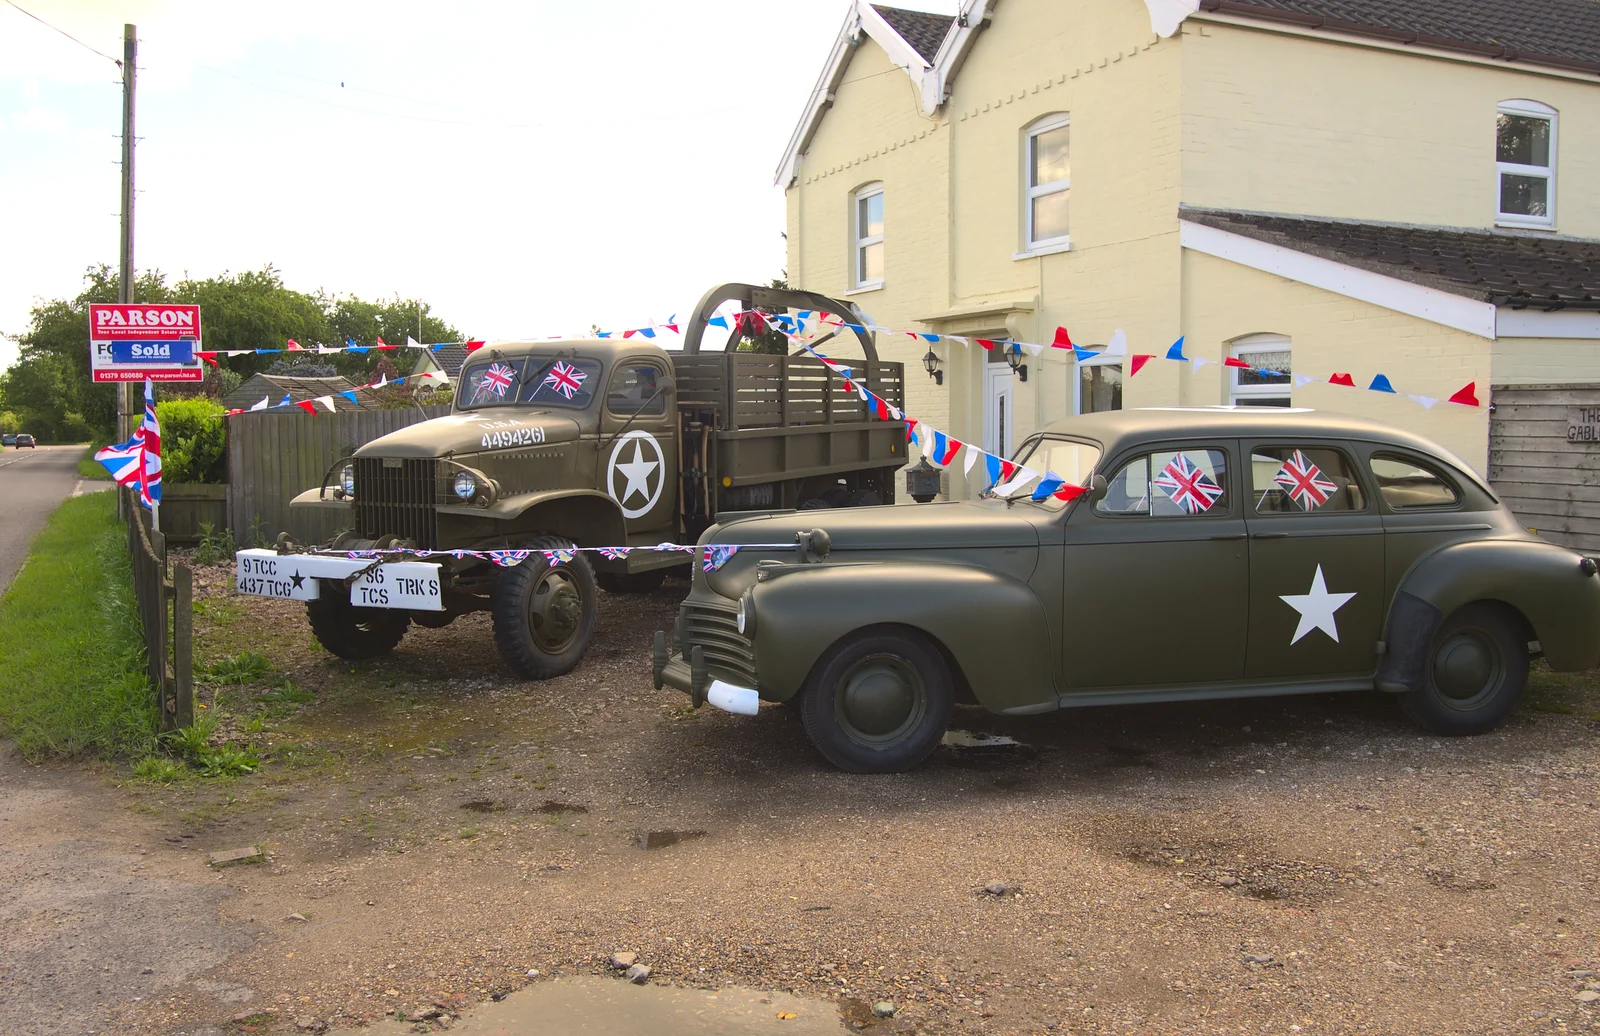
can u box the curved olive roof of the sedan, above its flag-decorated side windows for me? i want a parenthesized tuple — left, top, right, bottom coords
(1045, 406, 1482, 481)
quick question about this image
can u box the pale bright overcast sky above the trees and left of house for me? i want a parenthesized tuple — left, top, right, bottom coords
(0, 0, 957, 366)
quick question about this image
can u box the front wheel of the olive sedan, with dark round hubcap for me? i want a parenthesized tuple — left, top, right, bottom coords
(800, 630, 955, 774)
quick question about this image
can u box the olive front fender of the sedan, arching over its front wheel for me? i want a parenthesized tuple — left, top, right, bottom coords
(750, 561, 1059, 711)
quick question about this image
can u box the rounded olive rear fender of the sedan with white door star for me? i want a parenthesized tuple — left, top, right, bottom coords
(1376, 539, 1600, 692)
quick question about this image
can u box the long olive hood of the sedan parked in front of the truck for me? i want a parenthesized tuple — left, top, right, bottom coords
(702, 500, 1038, 550)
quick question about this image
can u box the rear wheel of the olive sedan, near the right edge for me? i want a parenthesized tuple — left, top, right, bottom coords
(1400, 601, 1528, 737)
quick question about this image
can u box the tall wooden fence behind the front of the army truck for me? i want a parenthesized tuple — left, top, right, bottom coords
(227, 406, 450, 547)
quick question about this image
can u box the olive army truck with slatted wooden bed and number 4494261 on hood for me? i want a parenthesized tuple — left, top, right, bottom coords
(237, 285, 906, 679)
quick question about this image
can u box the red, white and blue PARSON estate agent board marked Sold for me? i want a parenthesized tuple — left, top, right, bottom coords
(90, 302, 203, 382)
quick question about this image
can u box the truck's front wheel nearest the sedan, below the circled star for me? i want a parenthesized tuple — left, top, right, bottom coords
(490, 536, 600, 679)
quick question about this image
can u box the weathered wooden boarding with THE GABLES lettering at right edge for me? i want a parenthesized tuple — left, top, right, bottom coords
(1490, 382, 1600, 555)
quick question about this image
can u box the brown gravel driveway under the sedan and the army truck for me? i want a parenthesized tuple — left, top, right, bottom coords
(12, 568, 1600, 1033)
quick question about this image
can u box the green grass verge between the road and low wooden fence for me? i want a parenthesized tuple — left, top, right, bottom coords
(0, 492, 157, 758)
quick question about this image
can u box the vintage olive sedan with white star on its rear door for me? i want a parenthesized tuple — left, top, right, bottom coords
(654, 408, 1600, 772)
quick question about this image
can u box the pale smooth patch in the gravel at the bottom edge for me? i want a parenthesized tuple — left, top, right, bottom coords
(371, 977, 851, 1036)
